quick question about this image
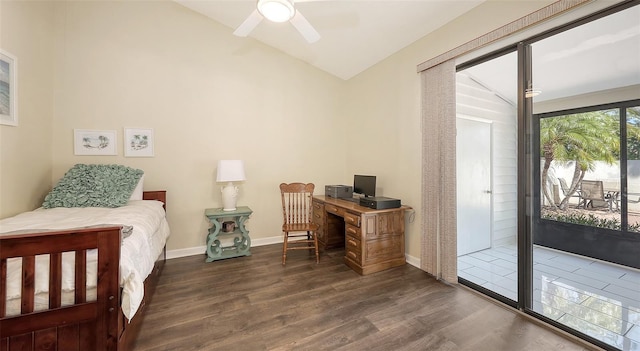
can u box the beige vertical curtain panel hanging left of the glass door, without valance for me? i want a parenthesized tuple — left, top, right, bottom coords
(420, 60, 458, 283)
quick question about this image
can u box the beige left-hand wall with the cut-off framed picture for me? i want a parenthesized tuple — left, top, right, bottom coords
(0, 1, 53, 218)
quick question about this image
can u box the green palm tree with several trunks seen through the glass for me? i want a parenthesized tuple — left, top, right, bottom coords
(540, 111, 620, 209)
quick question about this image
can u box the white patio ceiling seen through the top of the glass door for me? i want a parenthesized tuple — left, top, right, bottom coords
(465, 6, 640, 103)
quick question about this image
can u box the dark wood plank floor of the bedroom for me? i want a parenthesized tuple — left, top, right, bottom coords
(135, 245, 586, 351)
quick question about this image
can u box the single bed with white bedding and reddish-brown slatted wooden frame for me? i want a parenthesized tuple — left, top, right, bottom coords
(0, 166, 169, 351)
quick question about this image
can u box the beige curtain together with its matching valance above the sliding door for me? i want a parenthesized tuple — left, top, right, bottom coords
(417, 0, 590, 283)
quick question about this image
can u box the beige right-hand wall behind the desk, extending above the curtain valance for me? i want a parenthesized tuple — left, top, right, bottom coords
(345, 0, 554, 258)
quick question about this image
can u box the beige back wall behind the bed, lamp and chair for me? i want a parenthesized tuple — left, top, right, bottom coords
(52, 1, 345, 250)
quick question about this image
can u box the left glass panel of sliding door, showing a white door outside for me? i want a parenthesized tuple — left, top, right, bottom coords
(456, 51, 518, 302)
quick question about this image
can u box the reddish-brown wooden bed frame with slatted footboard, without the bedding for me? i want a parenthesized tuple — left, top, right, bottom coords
(0, 191, 166, 351)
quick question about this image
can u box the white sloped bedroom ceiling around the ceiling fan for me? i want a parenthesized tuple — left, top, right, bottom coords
(174, 0, 485, 80)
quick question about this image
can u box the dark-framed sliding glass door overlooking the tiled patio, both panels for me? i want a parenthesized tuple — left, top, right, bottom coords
(456, 1, 640, 350)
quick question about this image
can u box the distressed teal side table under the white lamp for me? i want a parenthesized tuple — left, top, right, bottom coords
(204, 206, 253, 262)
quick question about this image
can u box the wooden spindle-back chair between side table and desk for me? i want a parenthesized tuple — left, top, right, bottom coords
(280, 183, 320, 265)
